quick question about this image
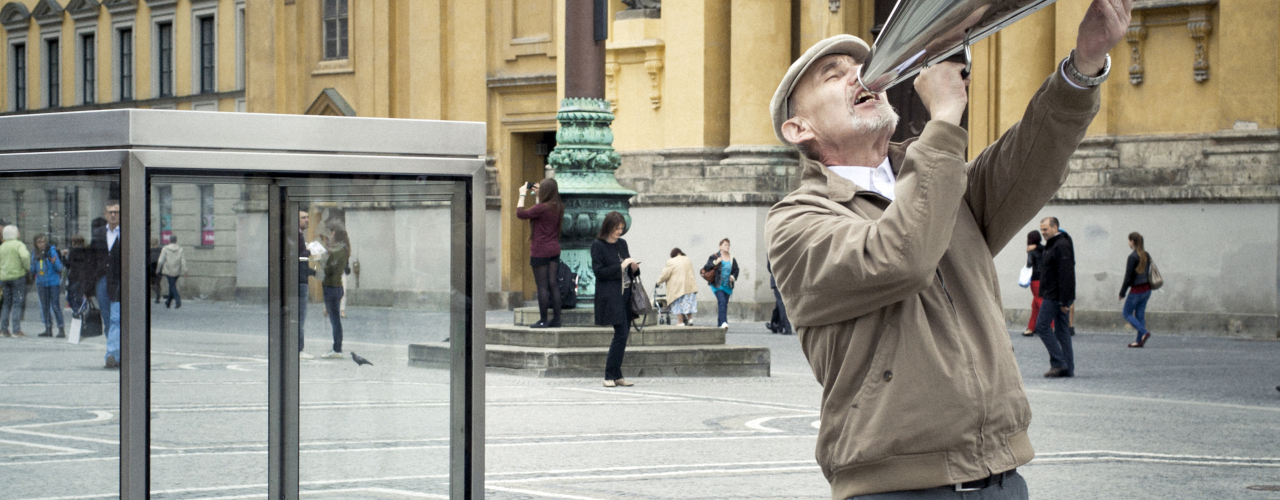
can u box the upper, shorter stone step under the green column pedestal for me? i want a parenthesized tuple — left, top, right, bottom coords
(485, 325, 727, 348)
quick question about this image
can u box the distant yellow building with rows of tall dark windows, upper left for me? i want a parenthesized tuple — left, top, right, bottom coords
(0, 0, 246, 114)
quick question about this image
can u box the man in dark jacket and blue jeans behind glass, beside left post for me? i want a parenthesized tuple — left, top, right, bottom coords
(88, 199, 123, 370)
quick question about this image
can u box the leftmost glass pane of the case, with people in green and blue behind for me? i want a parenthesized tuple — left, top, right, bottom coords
(0, 171, 120, 499)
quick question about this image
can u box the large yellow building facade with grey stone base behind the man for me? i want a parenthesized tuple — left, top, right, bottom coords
(244, 0, 1280, 331)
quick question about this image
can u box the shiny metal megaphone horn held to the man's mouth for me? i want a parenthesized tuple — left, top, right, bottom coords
(858, 0, 1053, 92)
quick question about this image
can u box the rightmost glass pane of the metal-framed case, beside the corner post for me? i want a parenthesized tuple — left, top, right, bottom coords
(285, 179, 467, 497)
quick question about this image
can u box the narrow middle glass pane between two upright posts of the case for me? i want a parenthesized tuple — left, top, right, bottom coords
(147, 176, 269, 496)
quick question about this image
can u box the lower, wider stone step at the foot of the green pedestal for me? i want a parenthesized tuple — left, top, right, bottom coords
(408, 343, 771, 380)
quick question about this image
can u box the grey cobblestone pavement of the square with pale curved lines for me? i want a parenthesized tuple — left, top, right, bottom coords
(0, 301, 1280, 500)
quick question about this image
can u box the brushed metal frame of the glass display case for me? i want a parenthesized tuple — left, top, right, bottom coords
(0, 110, 485, 500)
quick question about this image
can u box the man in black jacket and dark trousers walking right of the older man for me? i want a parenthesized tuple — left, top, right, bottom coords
(1036, 217, 1075, 377)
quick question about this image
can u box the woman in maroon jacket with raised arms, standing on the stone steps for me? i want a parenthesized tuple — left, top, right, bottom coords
(516, 179, 564, 329)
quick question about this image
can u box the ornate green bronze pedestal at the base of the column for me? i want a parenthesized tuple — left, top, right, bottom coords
(547, 97, 636, 306)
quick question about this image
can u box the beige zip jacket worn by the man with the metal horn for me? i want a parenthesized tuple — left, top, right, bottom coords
(765, 73, 1098, 500)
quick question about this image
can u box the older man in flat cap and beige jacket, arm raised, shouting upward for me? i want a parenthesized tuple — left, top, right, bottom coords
(765, 0, 1130, 500)
